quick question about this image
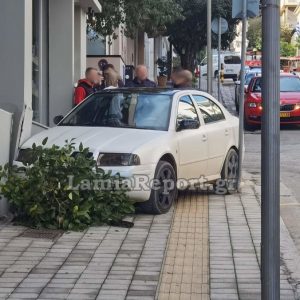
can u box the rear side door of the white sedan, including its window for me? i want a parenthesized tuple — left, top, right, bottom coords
(193, 94, 233, 177)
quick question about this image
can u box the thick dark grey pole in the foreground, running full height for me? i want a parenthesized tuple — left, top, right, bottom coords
(261, 0, 280, 300)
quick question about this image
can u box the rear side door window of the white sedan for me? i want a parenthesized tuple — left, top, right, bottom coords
(193, 95, 225, 124)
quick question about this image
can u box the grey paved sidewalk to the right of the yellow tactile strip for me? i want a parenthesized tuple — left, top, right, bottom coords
(209, 174, 300, 300)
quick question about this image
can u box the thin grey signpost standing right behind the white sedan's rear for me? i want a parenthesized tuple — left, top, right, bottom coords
(238, 0, 247, 189)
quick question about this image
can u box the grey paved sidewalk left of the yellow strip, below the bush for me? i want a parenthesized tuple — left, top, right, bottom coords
(0, 212, 172, 300)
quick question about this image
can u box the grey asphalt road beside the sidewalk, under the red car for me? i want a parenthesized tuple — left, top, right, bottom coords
(216, 79, 300, 251)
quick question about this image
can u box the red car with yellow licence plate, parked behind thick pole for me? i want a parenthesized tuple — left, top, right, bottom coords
(244, 73, 300, 130)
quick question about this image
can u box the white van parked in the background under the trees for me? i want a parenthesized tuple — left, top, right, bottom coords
(200, 53, 241, 81)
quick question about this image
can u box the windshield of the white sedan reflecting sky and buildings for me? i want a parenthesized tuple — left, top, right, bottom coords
(59, 91, 172, 131)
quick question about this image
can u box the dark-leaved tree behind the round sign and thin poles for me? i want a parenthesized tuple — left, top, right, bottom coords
(167, 0, 238, 71)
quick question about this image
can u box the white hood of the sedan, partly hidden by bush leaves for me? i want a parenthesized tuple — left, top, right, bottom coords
(21, 126, 168, 153)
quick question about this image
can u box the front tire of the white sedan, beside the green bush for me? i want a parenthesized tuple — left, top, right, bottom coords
(137, 161, 177, 215)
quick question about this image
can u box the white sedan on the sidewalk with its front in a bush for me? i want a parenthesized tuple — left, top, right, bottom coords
(19, 89, 238, 214)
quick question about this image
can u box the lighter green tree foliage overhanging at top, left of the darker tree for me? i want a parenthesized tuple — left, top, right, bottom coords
(88, 0, 182, 38)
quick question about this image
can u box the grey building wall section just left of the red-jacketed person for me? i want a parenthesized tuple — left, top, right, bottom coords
(49, 0, 74, 126)
